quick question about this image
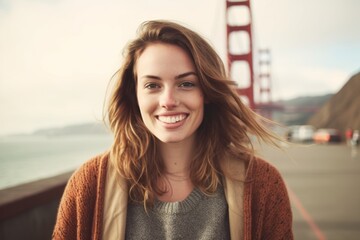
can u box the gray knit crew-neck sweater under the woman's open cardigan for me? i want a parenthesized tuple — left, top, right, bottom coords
(126, 188, 230, 240)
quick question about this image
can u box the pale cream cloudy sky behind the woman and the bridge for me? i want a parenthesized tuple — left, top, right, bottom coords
(0, 0, 360, 135)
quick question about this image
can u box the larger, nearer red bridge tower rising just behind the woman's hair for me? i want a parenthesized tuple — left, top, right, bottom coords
(226, 0, 255, 109)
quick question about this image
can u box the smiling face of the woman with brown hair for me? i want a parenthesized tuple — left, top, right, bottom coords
(136, 43, 204, 143)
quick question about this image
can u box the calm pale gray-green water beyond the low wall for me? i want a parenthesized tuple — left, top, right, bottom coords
(0, 135, 112, 189)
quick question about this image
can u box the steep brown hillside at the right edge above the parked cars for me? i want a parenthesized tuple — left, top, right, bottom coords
(308, 73, 360, 131)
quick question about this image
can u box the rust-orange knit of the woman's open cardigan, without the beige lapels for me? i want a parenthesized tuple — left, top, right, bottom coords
(53, 154, 293, 240)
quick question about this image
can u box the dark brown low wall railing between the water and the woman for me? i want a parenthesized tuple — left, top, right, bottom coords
(0, 172, 72, 240)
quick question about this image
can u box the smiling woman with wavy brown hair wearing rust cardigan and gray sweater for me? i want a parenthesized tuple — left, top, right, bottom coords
(53, 21, 293, 240)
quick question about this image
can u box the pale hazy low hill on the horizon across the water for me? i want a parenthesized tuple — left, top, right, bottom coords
(33, 123, 110, 136)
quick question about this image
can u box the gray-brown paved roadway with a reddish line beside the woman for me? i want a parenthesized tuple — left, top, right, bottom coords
(256, 144, 360, 240)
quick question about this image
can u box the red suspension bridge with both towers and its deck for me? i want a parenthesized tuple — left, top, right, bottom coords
(225, 0, 318, 118)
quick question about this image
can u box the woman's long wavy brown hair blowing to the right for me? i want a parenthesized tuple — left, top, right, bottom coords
(107, 21, 277, 206)
